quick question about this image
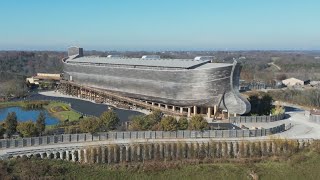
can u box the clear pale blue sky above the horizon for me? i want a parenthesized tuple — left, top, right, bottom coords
(0, 0, 320, 50)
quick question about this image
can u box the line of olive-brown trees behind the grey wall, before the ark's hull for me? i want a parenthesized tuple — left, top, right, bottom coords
(80, 110, 209, 134)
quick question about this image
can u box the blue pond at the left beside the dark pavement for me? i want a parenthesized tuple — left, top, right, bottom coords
(0, 107, 59, 125)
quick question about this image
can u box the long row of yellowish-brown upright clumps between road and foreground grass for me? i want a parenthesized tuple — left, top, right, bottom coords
(18, 140, 310, 164)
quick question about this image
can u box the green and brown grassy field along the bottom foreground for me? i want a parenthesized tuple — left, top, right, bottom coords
(0, 152, 320, 180)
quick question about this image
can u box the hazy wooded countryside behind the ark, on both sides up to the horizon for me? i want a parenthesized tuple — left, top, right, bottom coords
(0, 51, 320, 97)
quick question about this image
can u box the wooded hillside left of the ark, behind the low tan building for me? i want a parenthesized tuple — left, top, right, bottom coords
(0, 51, 66, 97)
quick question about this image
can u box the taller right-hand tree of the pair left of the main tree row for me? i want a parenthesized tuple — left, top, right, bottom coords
(100, 110, 120, 131)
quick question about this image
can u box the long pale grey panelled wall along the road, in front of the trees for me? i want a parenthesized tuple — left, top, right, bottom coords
(0, 124, 286, 149)
